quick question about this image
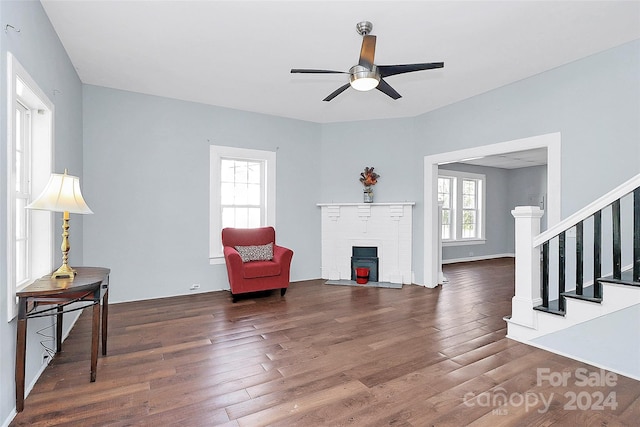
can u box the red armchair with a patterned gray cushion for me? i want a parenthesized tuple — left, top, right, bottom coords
(222, 227, 293, 302)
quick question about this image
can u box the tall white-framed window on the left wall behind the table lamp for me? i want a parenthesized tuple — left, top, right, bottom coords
(6, 53, 53, 321)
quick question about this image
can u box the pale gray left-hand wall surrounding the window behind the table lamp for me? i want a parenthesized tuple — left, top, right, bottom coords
(0, 0, 84, 424)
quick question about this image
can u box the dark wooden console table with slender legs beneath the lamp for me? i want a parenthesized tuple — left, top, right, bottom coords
(16, 267, 111, 412)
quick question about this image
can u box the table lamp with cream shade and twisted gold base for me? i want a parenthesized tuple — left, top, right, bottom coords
(26, 169, 93, 280)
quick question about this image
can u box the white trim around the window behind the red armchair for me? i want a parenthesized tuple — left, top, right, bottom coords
(209, 145, 276, 264)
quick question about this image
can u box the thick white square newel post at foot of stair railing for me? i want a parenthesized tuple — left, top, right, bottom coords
(511, 206, 544, 328)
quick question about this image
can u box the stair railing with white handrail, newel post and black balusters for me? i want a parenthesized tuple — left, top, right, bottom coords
(511, 174, 640, 327)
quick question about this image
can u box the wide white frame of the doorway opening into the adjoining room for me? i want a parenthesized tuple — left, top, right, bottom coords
(423, 132, 561, 288)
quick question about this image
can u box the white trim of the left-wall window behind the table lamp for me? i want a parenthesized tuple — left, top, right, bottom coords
(6, 52, 55, 321)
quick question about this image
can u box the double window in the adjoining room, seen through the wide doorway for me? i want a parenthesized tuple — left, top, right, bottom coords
(438, 170, 485, 243)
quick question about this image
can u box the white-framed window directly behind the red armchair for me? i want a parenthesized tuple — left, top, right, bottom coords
(209, 145, 276, 264)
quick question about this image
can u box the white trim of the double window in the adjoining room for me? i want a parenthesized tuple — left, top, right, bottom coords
(438, 169, 487, 246)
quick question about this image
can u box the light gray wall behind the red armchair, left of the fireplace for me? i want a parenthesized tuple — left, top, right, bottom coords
(83, 86, 322, 302)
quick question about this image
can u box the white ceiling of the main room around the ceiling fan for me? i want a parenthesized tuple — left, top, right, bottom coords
(42, 0, 640, 123)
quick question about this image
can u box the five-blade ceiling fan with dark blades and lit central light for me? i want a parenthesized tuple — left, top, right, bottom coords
(291, 21, 444, 101)
